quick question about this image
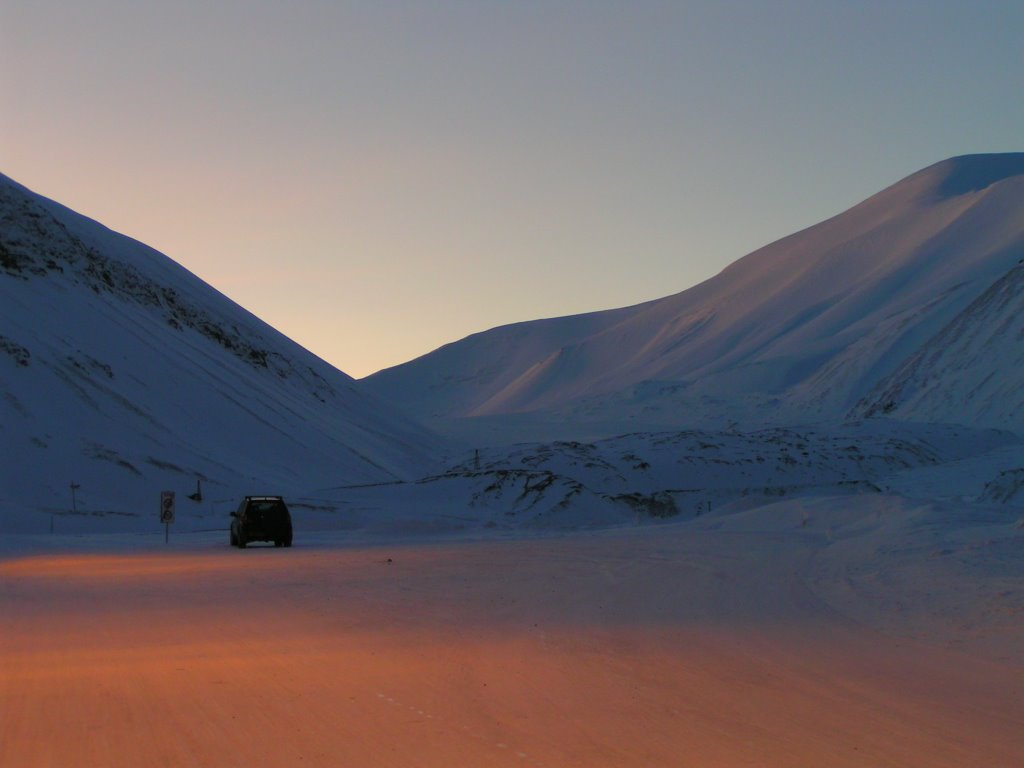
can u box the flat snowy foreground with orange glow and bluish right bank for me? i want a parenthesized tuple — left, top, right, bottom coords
(0, 494, 1024, 768)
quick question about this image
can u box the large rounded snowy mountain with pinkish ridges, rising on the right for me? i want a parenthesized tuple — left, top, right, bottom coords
(361, 153, 1024, 437)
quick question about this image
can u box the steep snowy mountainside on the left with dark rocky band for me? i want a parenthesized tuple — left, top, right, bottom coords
(0, 176, 446, 527)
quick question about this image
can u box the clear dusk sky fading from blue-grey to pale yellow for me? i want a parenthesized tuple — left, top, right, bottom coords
(0, 0, 1024, 377)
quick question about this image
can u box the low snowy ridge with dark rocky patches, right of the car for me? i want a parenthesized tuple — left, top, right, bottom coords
(282, 419, 1024, 534)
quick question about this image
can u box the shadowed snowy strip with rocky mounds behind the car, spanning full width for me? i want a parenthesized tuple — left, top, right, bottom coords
(9, 419, 1024, 547)
